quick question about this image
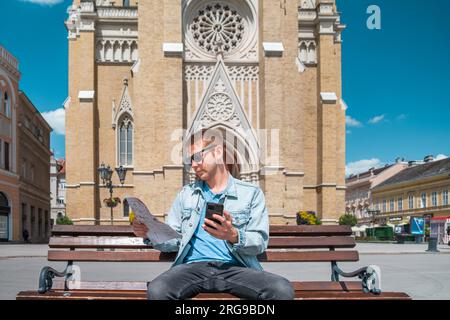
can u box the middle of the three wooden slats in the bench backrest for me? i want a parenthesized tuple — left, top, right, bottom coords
(49, 237, 356, 249)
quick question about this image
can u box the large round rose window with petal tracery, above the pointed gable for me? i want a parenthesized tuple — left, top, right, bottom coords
(190, 3, 245, 53)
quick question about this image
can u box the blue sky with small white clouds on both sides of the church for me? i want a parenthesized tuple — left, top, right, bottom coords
(0, 0, 450, 173)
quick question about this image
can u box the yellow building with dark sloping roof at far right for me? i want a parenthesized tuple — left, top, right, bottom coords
(369, 156, 450, 224)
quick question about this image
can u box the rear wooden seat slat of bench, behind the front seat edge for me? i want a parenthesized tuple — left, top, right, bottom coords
(53, 280, 362, 292)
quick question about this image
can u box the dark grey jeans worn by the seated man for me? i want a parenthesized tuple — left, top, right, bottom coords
(147, 261, 294, 300)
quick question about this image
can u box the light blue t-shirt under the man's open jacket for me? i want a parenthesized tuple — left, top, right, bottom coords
(184, 182, 241, 266)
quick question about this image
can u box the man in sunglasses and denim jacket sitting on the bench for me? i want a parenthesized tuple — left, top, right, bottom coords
(133, 129, 295, 300)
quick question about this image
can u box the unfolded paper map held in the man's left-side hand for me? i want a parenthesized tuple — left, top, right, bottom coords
(124, 197, 181, 245)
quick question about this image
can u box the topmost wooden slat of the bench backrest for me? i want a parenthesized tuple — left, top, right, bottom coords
(52, 225, 352, 237)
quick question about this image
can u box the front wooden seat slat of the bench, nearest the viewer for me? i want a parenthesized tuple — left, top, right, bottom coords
(17, 290, 411, 300)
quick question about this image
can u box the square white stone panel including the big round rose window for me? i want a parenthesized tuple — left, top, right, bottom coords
(183, 0, 258, 62)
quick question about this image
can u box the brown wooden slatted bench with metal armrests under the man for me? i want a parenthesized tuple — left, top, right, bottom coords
(17, 225, 410, 300)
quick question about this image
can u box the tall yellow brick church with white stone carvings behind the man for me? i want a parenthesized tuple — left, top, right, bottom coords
(65, 0, 346, 224)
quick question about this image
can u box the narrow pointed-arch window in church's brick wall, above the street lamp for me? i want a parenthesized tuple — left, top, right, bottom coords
(117, 114, 133, 166)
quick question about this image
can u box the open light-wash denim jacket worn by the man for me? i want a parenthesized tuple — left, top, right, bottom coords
(146, 174, 269, 270)
